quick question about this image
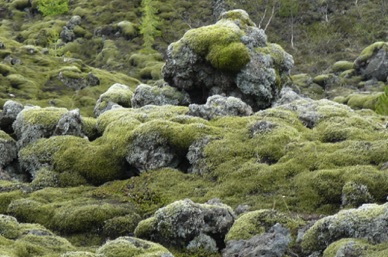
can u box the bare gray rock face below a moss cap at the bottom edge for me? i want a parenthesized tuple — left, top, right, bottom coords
(222, 223, 291, 257)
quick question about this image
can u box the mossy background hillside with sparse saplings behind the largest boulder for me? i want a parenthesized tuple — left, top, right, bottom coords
(0, 0, 388, 110)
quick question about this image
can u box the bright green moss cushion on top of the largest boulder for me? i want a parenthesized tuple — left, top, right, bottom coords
(178, 23, 250, 72)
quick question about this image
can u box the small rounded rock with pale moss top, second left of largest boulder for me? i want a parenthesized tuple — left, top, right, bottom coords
(94, 83, 133, 117)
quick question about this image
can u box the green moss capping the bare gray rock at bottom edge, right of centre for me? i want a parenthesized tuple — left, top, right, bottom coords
(225, 209, 304, 242)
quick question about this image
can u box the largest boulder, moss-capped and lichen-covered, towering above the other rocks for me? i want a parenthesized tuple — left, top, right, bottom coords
(162, 10, 294, 111)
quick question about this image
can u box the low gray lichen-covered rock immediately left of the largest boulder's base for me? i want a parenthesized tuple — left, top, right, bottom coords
(132, 84, 190, 108)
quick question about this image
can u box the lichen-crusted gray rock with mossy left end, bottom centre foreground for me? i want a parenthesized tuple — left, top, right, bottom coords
(135, 199, 235, 249)
